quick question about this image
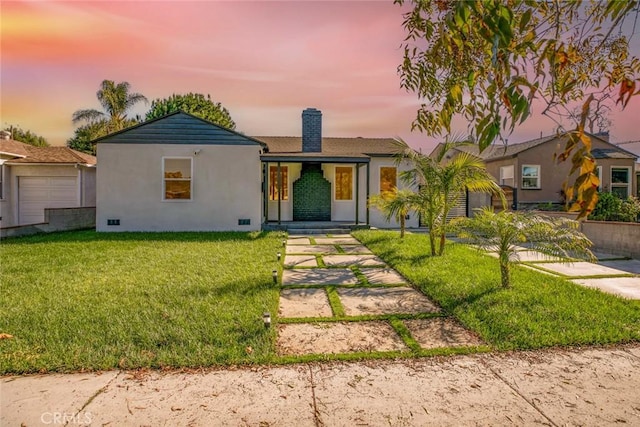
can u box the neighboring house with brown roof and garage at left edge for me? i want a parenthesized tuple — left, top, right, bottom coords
(0, 132, 96, 228)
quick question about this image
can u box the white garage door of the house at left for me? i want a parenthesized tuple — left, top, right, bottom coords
(18, 176, 79, 224)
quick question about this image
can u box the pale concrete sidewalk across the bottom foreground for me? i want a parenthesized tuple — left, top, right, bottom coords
(0, 344, 640, 426)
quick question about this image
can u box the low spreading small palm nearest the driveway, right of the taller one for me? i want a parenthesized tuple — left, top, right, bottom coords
(453, 207, 595, 288)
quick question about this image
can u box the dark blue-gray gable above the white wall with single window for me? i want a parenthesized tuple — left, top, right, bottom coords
(95, 111, 263, 145)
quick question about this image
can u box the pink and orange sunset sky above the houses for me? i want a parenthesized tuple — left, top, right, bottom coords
(0, 0, 640, 151)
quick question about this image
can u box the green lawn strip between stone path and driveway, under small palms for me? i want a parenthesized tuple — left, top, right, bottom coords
(354, 230, 640, 350)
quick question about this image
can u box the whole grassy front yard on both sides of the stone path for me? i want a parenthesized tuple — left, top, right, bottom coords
(0, 230, 640, 374)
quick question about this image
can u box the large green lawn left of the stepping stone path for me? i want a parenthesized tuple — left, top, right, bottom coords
(0, 231, 282, 373)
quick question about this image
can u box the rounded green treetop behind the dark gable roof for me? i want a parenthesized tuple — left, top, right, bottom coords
(146, 92, 236, 130)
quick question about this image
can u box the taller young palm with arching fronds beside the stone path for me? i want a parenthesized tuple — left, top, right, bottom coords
(397, 140, 506, 255)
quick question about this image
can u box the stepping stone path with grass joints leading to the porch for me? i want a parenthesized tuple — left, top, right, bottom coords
(277, 235, 484, 355)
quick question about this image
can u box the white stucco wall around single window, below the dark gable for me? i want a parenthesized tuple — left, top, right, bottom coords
(96, 143, 262, 231)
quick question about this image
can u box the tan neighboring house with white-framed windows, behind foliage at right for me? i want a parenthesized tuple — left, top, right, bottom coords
(436, 134, 638, 208)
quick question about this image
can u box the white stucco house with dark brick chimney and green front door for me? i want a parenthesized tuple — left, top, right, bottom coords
(96, 109, 418, 231)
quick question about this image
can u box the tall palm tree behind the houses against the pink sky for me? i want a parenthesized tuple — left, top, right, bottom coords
(72, 80, 147, 136)
